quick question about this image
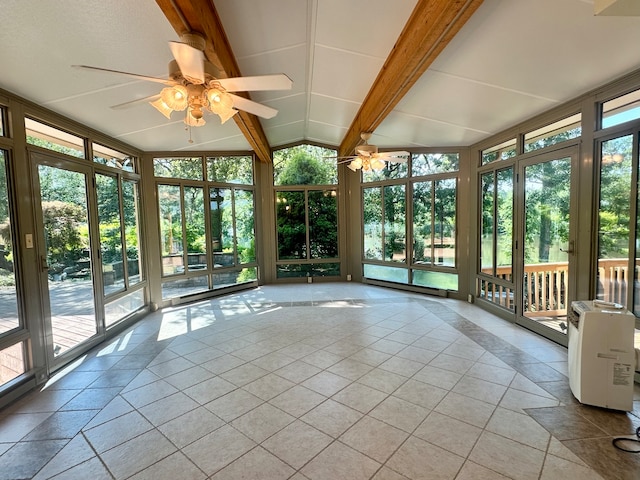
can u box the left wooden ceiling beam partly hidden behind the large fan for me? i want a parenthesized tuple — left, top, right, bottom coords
(156, 0, 271, 163)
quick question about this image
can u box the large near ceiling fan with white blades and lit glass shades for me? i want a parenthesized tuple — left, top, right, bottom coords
(73, 33, 293, 127)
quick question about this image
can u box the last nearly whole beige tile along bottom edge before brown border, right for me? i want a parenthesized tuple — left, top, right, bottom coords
(469, 432, 545, 480)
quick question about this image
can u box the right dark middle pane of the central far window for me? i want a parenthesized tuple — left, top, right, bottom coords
(308, 189, 338, 258)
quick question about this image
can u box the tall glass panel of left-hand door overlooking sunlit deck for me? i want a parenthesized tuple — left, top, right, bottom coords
(38, 165, 97, 355)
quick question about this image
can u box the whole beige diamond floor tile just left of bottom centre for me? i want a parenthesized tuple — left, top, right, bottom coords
(262, 420, 333, 469)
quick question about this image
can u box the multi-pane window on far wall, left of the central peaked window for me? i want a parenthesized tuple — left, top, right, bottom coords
(154, 155, 258, 299)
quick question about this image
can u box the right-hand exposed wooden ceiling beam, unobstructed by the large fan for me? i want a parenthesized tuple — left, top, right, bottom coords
(338, 0, 483, 156)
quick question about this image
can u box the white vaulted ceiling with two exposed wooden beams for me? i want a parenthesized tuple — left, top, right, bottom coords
(0, 0, 640, 160)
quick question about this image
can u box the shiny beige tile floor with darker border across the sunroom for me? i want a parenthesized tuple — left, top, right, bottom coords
(0, 283, 640, 480)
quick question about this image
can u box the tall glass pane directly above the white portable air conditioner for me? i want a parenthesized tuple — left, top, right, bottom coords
(596, 135, 633, 306)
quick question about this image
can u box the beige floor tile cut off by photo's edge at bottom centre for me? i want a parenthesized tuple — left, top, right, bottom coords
(302, 442, 380, 480)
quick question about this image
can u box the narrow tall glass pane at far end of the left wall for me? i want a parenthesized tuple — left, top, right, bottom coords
(122, 180, 144, 286)
